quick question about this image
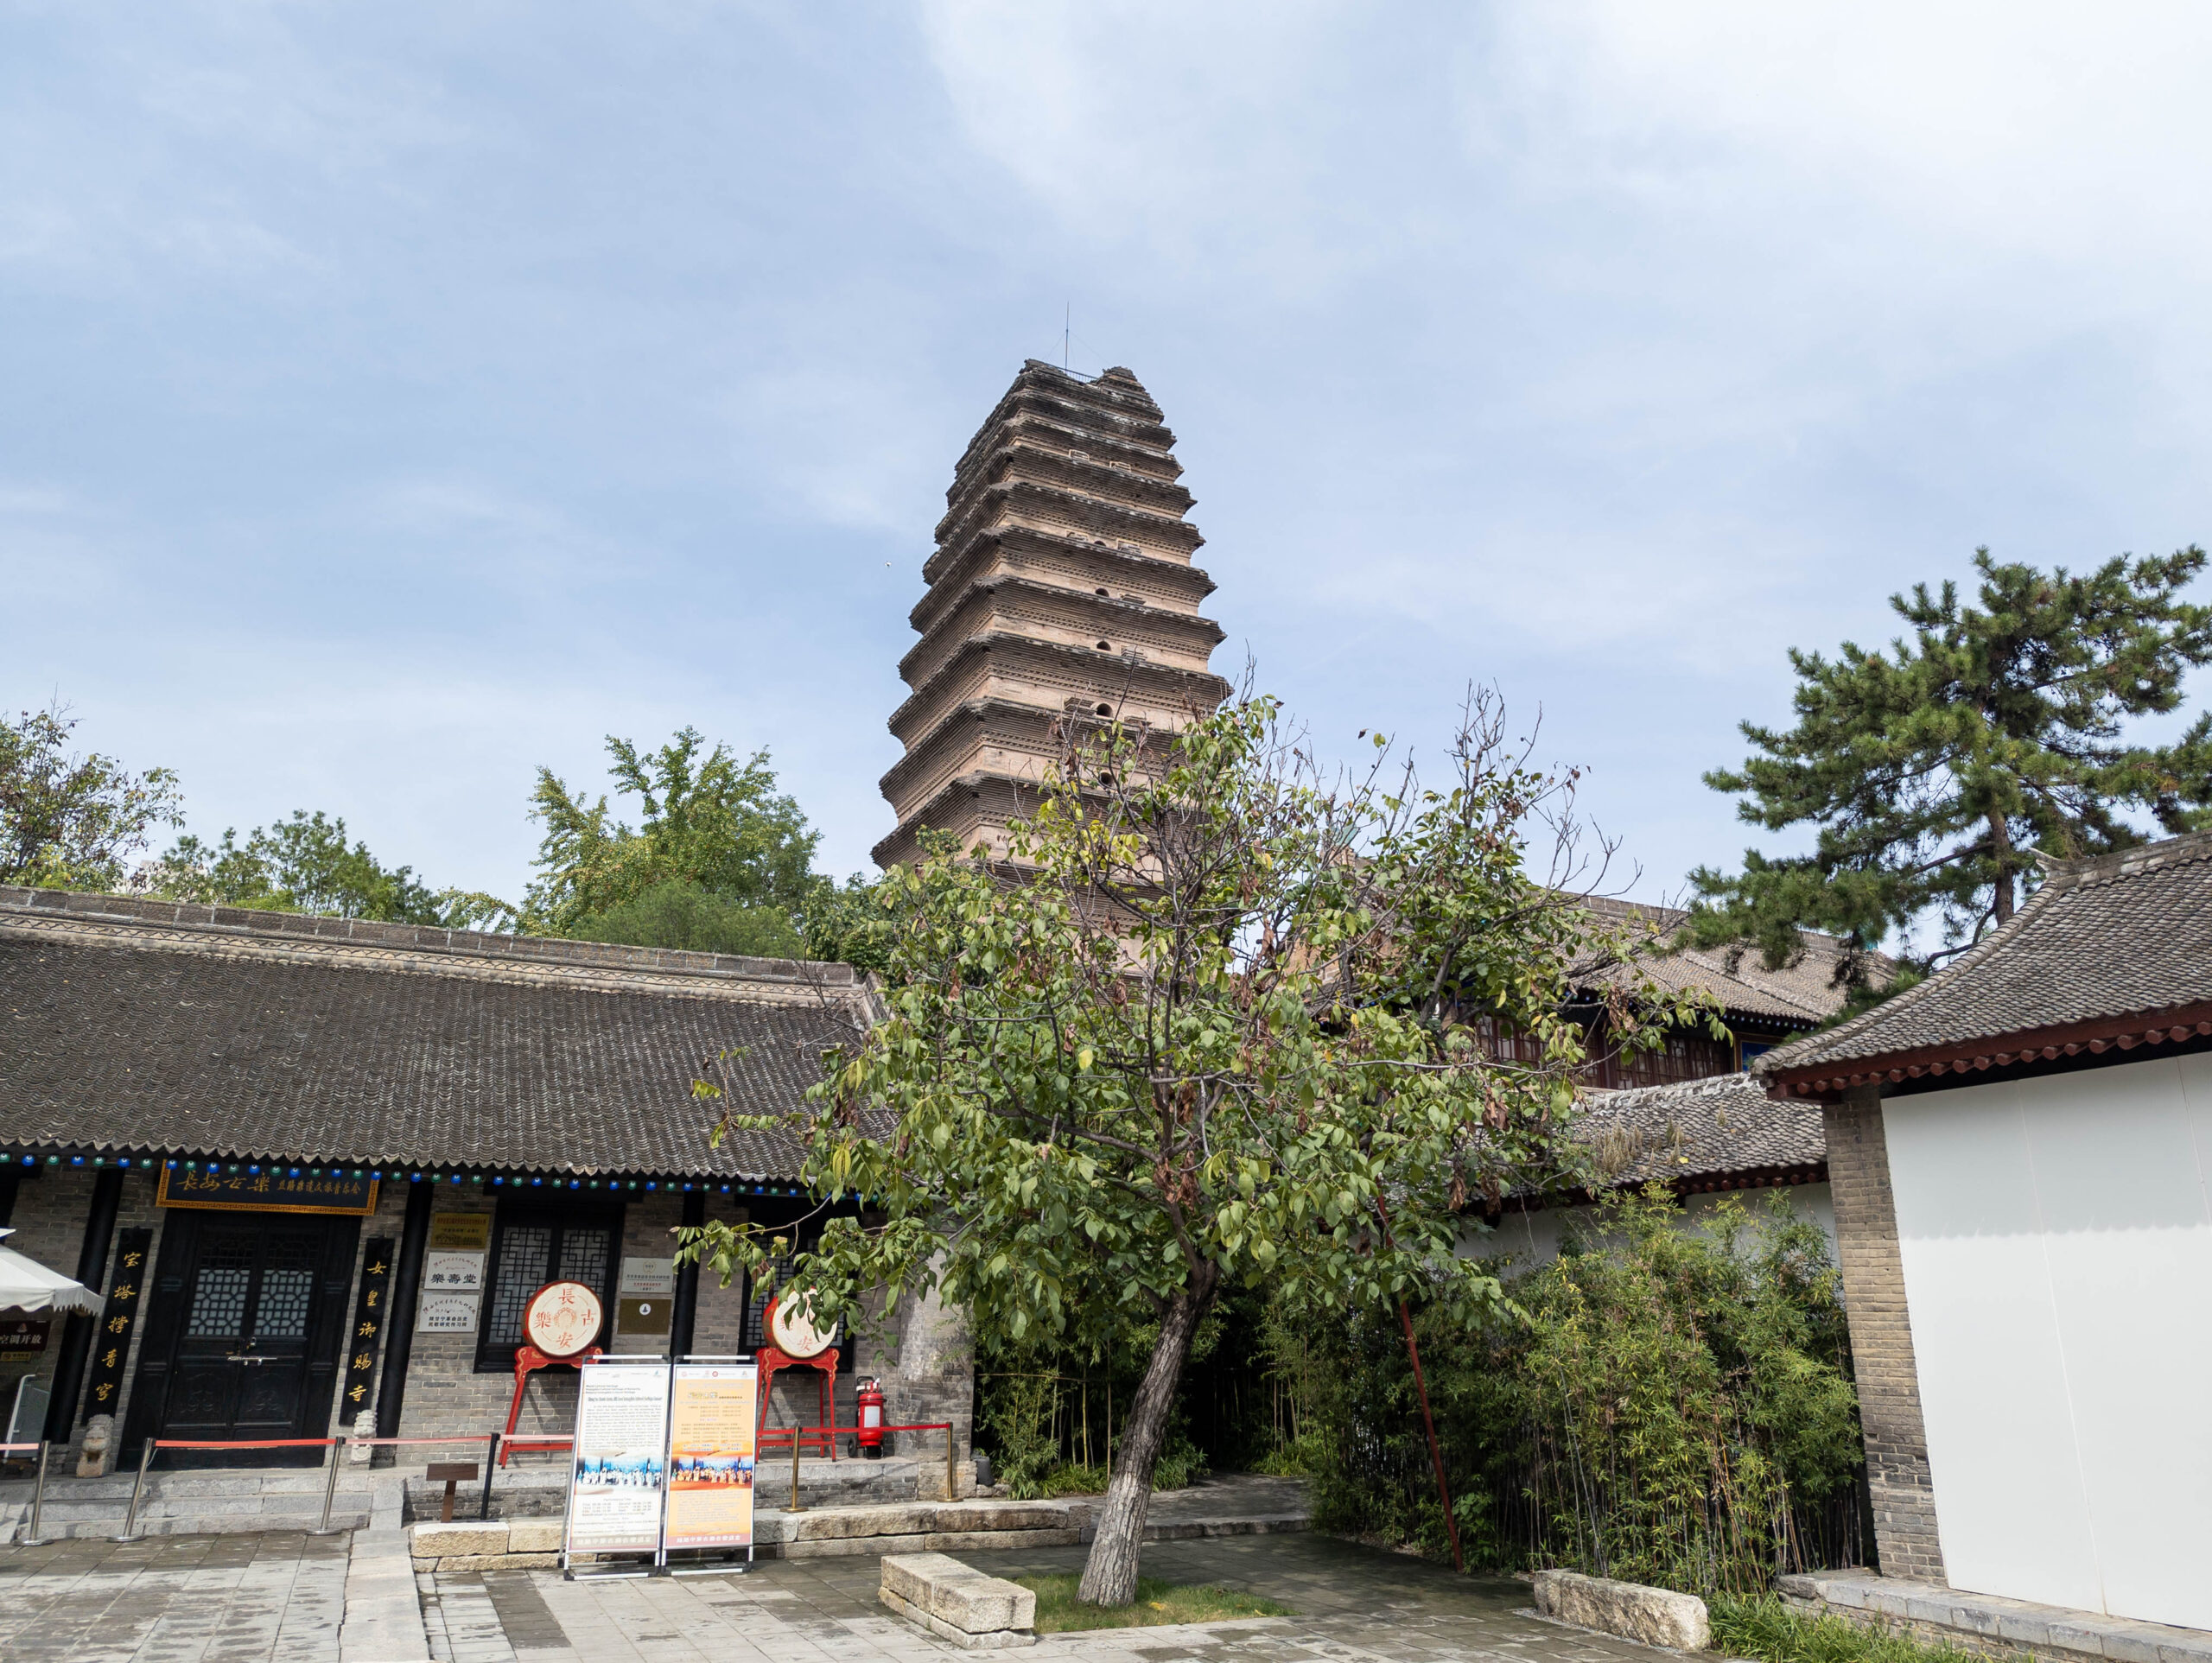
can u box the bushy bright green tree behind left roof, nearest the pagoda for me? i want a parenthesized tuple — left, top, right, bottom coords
(522, 727, 821, 957)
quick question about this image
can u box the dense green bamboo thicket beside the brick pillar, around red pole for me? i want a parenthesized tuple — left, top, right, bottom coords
(1272, 1190, 1860, 1592)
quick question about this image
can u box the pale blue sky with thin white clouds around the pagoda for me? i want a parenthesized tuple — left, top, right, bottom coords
(0, 0, 2212, 898)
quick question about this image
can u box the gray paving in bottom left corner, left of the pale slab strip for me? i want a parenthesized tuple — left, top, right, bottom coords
(0, 1530, 349, 1663)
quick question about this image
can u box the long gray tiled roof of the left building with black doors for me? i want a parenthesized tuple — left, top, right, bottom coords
(0, 889, 869, 1178)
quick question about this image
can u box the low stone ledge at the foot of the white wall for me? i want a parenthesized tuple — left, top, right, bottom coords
(1777, 1570, 2212, 1663)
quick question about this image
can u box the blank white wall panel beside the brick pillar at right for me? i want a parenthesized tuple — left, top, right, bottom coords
(1883, 1057, 2212, 1628)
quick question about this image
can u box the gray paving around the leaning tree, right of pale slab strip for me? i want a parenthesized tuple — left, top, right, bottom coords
(425, 1535, 1666, 1663)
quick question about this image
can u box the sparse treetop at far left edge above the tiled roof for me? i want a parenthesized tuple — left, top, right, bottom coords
(0, 706, 183, 889)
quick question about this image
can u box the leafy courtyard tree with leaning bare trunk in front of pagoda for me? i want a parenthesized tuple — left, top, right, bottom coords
(686, 696, 1712, 1605)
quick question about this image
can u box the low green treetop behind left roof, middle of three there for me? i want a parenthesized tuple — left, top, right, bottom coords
(146, 809, 469, 924)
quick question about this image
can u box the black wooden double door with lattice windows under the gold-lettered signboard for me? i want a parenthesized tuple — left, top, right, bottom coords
(126, 1212, 360, 1466)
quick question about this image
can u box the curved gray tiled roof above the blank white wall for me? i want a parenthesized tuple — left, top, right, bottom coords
(1757, 832, 2212, 1077)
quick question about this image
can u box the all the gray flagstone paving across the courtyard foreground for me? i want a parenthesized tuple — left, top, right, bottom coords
(0, 1533, 1689, 1663)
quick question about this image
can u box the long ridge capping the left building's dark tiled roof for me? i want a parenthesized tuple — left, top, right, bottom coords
(0, 885, 861, 987)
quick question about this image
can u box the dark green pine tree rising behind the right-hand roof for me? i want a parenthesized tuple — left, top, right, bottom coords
(1686, 546, 2212, 973)
